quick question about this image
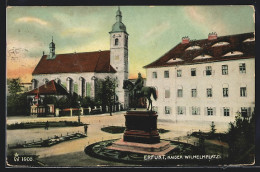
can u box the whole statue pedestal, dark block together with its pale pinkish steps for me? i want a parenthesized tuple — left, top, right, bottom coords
(107, 111, 174, 155)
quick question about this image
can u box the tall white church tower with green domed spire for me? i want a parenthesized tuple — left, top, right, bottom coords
(109, 7, 129, 108)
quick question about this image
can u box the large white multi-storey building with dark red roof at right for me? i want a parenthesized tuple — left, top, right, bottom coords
(145, 33, 255, 122)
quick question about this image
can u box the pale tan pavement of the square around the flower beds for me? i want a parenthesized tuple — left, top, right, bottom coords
(6, 112, 228, 157)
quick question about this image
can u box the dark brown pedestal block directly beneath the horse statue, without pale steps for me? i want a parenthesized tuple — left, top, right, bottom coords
(123, 111, 160, 144)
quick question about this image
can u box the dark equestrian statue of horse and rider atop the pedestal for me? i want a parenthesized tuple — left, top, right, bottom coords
(123, 73, 157, 111)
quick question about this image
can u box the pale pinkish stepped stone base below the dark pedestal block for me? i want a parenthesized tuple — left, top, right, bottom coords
(107, 139, 175, 155)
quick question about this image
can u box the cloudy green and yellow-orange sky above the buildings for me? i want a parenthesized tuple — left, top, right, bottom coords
(6, 5, 255, 82)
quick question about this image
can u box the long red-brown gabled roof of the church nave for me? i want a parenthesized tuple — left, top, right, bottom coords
(32, 50, 116, 75)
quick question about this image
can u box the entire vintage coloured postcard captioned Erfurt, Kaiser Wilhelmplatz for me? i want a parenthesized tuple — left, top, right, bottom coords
(6, 5, 256, 168)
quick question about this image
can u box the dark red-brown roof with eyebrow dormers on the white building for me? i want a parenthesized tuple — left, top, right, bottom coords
(144, 33, 255, 68)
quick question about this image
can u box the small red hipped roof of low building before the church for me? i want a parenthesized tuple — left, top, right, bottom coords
(27, 80, 68, 95)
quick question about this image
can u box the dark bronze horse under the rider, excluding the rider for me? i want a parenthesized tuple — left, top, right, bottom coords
(123, 80, 157, 111)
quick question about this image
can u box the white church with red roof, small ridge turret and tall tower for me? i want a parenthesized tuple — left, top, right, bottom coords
(32, 8, 129, 108)
